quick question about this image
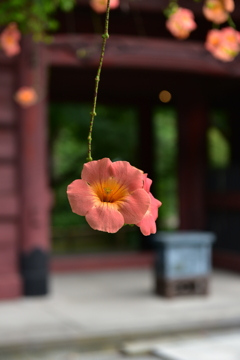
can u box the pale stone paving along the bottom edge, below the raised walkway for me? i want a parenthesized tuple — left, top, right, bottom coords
(3, 330, 240, 360)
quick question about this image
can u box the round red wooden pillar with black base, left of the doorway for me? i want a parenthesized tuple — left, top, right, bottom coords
(19, 38, 50, 295)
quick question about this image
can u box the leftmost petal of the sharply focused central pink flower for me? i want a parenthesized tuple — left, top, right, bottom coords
(67, 180, 94, 216)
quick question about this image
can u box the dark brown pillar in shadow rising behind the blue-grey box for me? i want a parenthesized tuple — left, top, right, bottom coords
(178, 90, 208, 230)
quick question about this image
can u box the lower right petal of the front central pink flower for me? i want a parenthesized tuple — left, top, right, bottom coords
(118, 189, 150, 224)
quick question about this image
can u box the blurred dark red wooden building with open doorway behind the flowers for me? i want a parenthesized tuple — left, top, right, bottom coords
(0, 0, 240, 299)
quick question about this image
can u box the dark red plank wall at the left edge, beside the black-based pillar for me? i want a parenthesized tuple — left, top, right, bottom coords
(0, 61, 22, 300)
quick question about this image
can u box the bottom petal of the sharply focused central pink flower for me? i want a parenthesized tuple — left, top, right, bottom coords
(86, 202, 124, 233)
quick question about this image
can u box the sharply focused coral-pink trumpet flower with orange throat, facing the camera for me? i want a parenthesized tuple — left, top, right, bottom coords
(67, 158, 151, 233)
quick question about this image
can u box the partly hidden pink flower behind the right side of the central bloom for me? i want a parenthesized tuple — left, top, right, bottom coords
(137, 174, 162, 235)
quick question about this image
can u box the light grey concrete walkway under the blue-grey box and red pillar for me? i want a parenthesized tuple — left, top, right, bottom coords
(0, 269, 240, 359)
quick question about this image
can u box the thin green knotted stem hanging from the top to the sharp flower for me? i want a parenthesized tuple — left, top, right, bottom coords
(87, 0, 110, 161)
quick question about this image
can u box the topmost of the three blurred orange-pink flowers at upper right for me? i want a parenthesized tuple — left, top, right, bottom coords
(203, 0, 235, 24)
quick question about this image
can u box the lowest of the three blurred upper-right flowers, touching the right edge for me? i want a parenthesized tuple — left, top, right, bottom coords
(205, 27, 240, 62)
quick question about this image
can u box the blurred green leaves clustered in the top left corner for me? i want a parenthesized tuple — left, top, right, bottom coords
(0, 0, 75, 41)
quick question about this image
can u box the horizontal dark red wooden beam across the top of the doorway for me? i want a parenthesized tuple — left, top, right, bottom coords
(46, 34, 240, 78)
